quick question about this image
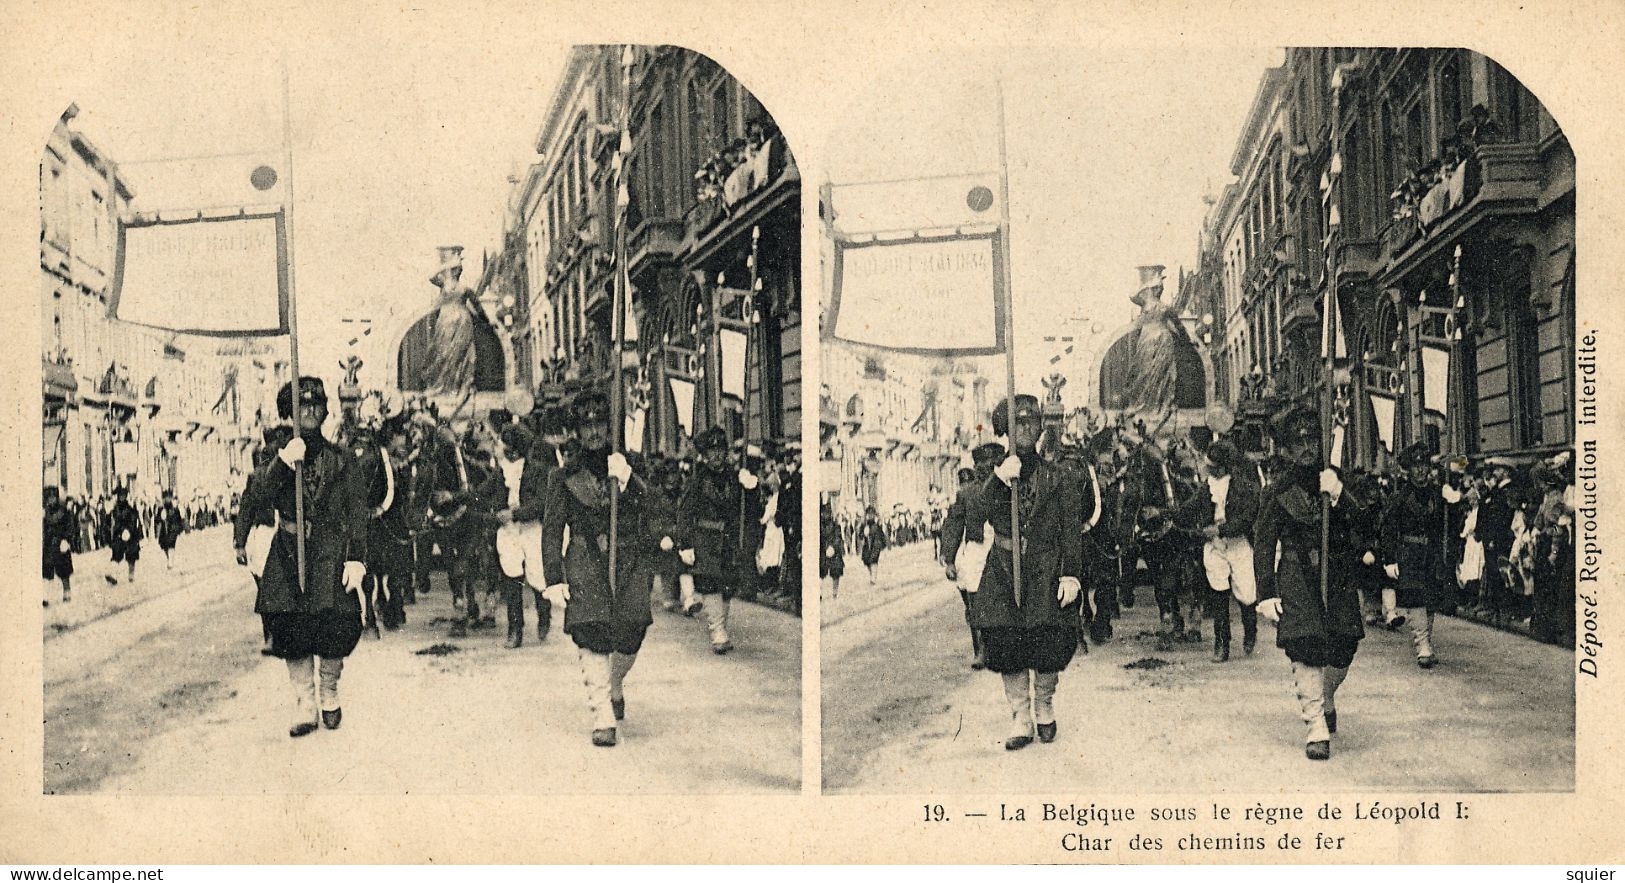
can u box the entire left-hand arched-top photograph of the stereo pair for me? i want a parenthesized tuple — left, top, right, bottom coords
(39, 46, 803, 795)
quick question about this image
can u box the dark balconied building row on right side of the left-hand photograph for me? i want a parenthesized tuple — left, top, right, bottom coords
(514, 46, 801, 454)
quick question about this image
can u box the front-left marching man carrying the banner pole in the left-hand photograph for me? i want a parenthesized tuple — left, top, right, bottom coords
(237, 377, 369, 737)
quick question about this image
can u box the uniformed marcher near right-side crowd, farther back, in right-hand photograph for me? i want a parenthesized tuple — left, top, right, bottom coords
(1383, 442, 1454, 668)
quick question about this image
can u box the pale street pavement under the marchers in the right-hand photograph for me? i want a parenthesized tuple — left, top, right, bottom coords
(822, 543, 1575, 794)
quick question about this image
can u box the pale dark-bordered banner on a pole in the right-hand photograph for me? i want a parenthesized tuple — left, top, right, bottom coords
(824, 233, 1009, 356)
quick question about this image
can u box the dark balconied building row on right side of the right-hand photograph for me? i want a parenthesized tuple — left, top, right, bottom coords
(1209, 49, 1575, 463)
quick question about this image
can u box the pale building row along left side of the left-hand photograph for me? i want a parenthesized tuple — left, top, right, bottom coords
(39, 107, 266, 501)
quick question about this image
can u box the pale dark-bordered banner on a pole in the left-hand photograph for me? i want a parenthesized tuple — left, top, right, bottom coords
(107, 211, 289, 337)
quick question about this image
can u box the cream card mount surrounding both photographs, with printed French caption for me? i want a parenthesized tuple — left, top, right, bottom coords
(0, 0, 1625, 865)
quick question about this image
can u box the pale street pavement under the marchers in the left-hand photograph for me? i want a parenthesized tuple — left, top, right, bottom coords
(44, 528, 801, 795)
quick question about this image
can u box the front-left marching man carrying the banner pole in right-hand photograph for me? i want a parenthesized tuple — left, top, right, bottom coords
(970, 395, 1086, 751)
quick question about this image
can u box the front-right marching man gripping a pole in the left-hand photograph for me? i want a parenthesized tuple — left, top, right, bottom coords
(541, 392, 653, 748)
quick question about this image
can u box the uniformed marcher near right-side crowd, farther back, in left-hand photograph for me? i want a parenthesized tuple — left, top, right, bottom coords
(676, 426, 746, 655)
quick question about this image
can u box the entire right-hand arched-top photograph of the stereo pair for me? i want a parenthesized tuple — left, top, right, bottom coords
(817, 47, 1584, 794)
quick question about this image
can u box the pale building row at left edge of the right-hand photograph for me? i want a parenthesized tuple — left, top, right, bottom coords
(819, 340, 981, 515)
